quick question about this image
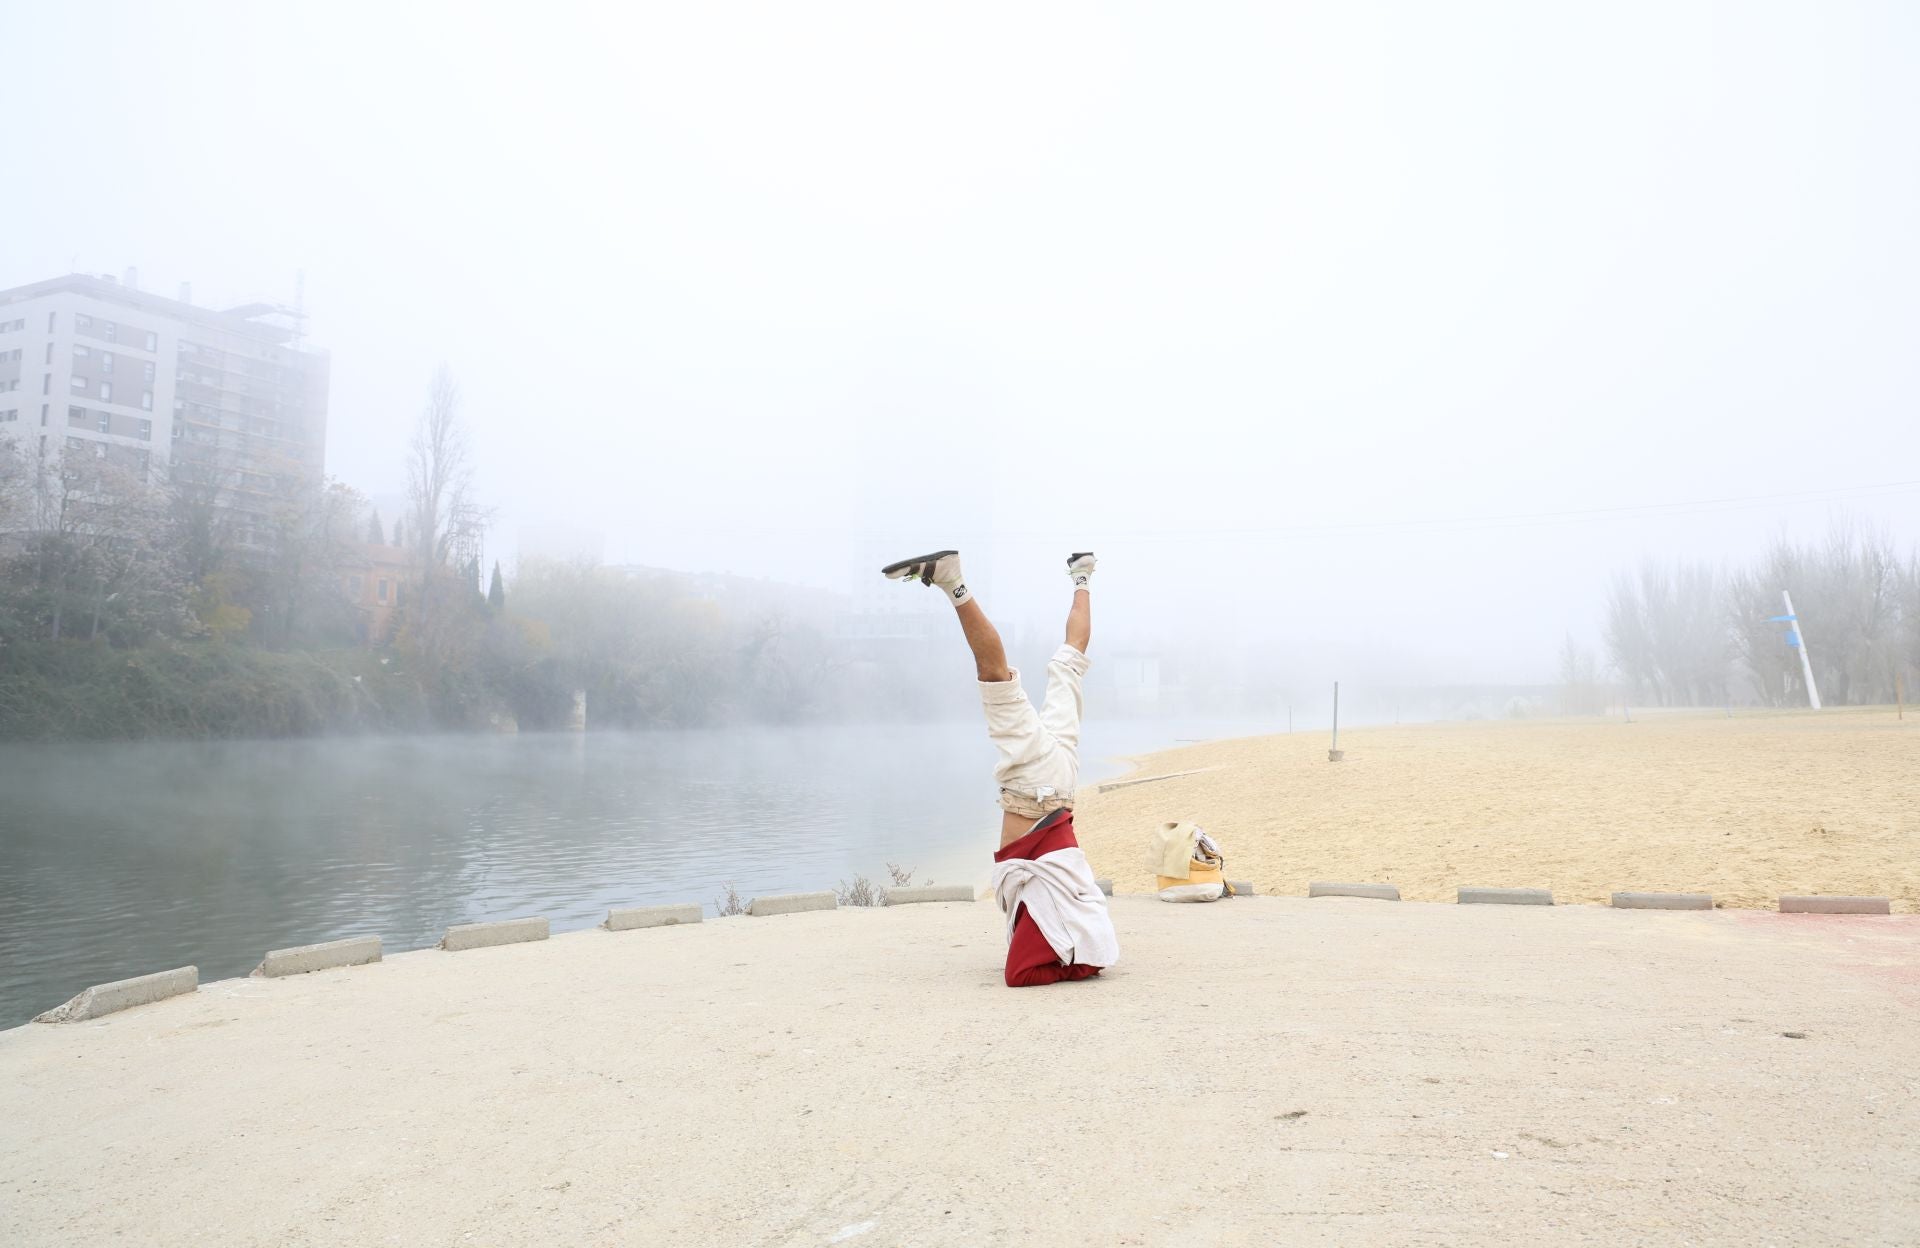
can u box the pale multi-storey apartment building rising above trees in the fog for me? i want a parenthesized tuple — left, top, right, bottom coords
(0, 269, 328, 545)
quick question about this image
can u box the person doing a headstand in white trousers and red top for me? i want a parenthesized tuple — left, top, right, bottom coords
(881, 551, 1119, 989)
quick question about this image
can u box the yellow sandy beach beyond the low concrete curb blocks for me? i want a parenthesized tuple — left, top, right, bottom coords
(1075, 707, 1920, 912)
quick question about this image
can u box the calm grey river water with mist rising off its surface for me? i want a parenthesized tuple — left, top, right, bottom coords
(0, 720, 1273, 1027)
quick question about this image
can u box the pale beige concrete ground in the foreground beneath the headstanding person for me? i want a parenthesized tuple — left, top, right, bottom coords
(0, 895, 1920, 1248)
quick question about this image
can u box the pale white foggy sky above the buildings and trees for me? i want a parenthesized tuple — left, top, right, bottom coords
(0, 2, 1920, 682)
